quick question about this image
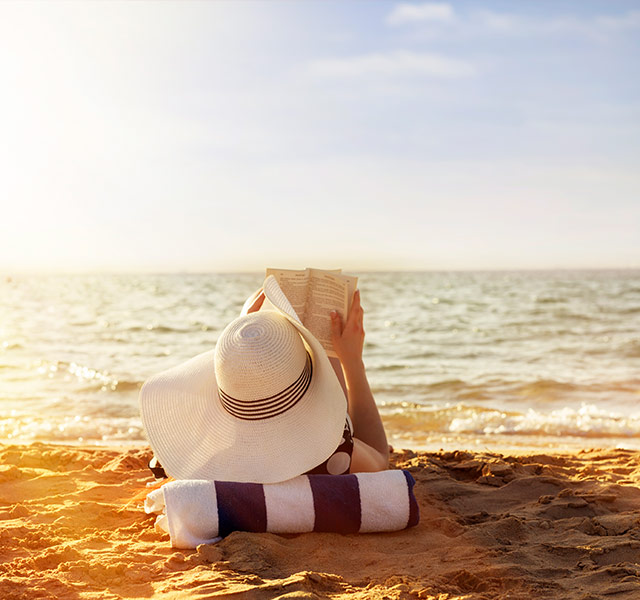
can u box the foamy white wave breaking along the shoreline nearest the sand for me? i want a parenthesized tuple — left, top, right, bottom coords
(5, 402, 640, 445)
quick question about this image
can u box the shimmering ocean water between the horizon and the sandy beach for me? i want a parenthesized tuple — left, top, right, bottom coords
(0, 271, 640, 450)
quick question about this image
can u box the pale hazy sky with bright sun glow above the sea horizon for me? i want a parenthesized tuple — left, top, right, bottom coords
(0, 0, 640, 273)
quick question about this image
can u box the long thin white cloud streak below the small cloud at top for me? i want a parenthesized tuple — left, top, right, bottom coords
(310, 50, 476, 78)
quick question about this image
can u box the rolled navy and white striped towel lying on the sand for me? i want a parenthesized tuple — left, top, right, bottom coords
(145, 470, 419, 548)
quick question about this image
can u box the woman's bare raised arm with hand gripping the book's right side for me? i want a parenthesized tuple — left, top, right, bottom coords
(331, 290, 389, 472)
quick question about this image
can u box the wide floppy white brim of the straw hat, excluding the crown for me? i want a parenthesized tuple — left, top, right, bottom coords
(140, 276, 347, 483)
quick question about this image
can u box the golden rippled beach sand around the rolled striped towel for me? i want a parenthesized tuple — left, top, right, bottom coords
(0, 444, 640, 600)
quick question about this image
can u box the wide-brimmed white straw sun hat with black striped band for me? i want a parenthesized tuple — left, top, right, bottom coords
(140, 276, 347, 483)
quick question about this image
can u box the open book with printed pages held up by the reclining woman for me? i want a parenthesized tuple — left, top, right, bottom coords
(266, 269, 358, 357)
